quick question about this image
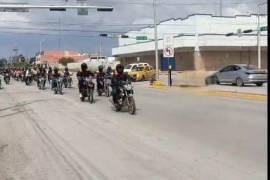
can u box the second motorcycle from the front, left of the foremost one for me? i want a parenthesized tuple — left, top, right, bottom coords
(80, 77, 95, 104)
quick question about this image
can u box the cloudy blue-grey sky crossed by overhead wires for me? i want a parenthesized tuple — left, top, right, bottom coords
(0, 0, 267, 57)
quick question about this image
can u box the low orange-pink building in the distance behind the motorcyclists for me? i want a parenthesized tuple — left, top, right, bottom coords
(36, 51, 89, 66)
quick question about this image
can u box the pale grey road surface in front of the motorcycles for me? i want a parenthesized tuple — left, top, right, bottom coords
(0, 81, 267, 180)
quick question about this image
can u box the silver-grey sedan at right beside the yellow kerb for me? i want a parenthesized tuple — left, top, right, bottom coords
(205, 64, 267, 86)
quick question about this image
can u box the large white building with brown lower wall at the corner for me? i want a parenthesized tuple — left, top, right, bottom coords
(112, 14, 267, 71)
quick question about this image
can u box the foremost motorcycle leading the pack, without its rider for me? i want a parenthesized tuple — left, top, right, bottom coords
(114, 81, 136, 115)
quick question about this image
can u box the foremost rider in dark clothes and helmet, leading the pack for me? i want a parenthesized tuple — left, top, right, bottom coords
(111, 64, 130, 104)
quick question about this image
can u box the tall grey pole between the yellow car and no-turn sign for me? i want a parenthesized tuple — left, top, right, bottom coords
(153, 0, 159, 80)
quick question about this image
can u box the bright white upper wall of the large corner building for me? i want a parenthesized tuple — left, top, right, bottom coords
(118, 15, 267, 46)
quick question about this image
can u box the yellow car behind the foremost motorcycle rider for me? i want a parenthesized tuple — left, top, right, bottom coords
(128, 66, 155, 81)
